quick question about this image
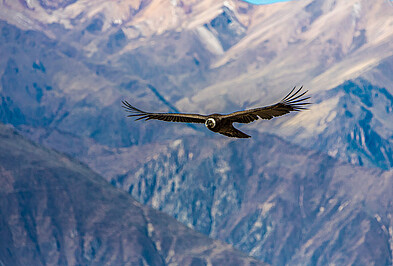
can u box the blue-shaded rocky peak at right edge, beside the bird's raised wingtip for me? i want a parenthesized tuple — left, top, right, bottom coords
(262, 78, 393, 169)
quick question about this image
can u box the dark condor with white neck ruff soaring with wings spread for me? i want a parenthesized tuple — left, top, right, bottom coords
(122, 86, 310, 138)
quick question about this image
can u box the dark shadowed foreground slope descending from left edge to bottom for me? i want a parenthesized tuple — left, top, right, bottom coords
(0, 125, 262, 265)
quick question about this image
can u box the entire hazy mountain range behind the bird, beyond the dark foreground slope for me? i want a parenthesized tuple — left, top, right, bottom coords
(0, 0, 393, 265)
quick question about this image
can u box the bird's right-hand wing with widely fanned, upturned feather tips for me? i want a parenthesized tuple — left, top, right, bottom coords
(222, 86, 310, 123)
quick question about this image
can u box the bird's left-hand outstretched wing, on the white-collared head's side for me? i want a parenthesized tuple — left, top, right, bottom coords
(122, 101, 207, 123)
